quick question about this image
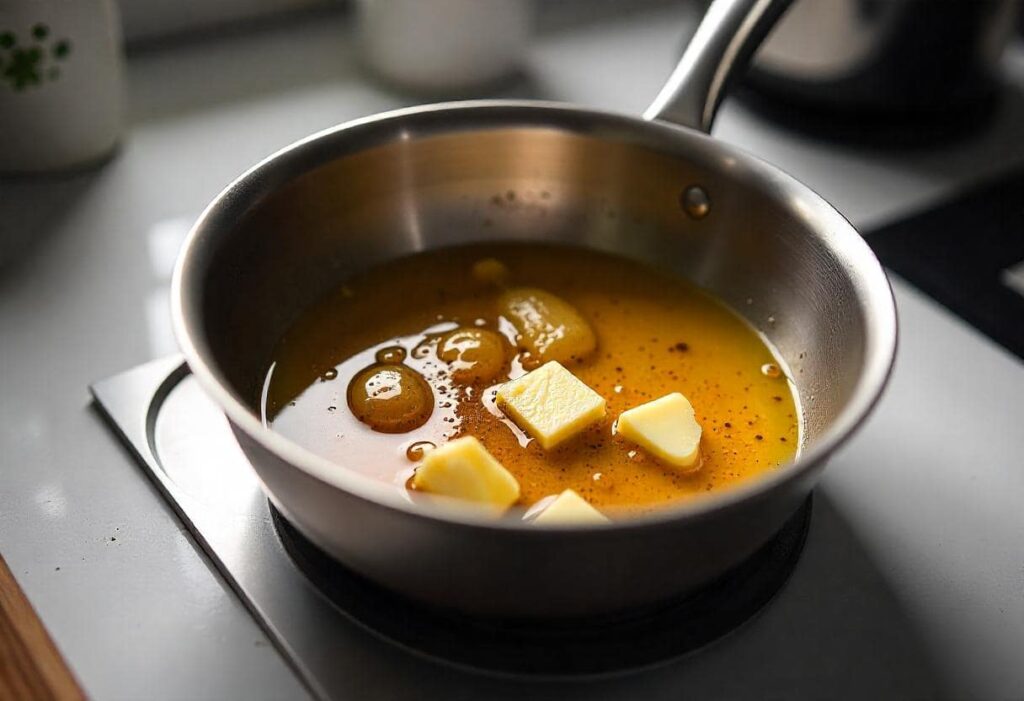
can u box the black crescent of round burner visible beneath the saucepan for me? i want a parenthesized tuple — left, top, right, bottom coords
(271, 497, 811, 676)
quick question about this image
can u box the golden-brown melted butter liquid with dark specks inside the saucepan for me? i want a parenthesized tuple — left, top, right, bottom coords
(263, 244, 800, 508)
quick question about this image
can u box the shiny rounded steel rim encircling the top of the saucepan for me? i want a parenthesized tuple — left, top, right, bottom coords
(171, 100, 898, 535)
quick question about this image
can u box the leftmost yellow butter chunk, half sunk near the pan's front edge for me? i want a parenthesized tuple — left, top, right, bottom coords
(413, 436, 519, 511)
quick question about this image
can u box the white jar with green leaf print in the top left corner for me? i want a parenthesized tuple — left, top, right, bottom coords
(0, 0, 124, 173)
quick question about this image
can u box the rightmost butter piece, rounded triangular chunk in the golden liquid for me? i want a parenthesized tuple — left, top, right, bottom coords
(617, 392, 700, 471)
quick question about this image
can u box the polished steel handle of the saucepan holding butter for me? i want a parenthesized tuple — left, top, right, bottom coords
(643, 0, 792, 133)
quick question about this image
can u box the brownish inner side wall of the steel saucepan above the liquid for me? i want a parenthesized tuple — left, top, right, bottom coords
(199, 126, 866, 443)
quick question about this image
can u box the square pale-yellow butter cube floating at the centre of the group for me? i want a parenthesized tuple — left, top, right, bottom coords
(497, 360, 604, 449)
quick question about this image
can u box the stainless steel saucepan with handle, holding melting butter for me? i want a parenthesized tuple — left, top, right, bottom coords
(172, 0, 896, 617)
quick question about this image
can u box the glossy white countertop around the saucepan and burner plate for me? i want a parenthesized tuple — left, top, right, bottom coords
(0, 8, 1024, 699)
